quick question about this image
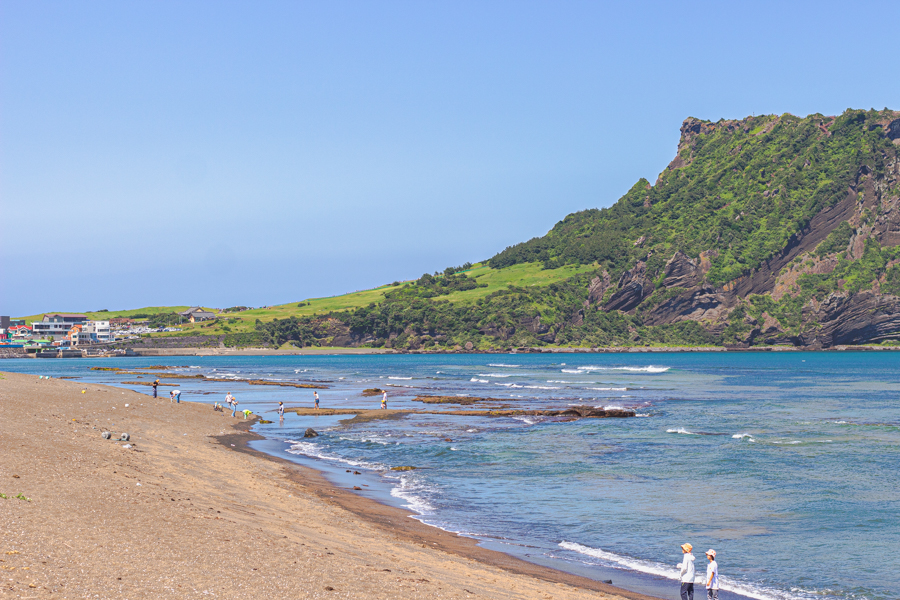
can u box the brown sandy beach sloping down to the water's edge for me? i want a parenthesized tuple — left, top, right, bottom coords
(0, 373, 660, 600)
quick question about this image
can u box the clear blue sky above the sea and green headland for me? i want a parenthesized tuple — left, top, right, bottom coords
(0, 0, 900, 315)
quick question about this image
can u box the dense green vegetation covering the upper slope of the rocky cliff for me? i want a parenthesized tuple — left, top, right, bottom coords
(490, 110, 894, 284)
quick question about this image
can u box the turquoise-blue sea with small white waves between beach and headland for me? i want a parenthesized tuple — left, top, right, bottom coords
(0, 352, 900, 600)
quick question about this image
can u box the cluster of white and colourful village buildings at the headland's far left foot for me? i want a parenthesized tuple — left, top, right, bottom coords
(0, 306, 217, 358)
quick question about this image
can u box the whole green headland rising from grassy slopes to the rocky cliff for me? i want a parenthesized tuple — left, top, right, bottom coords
(17, 109, 900, 351)
